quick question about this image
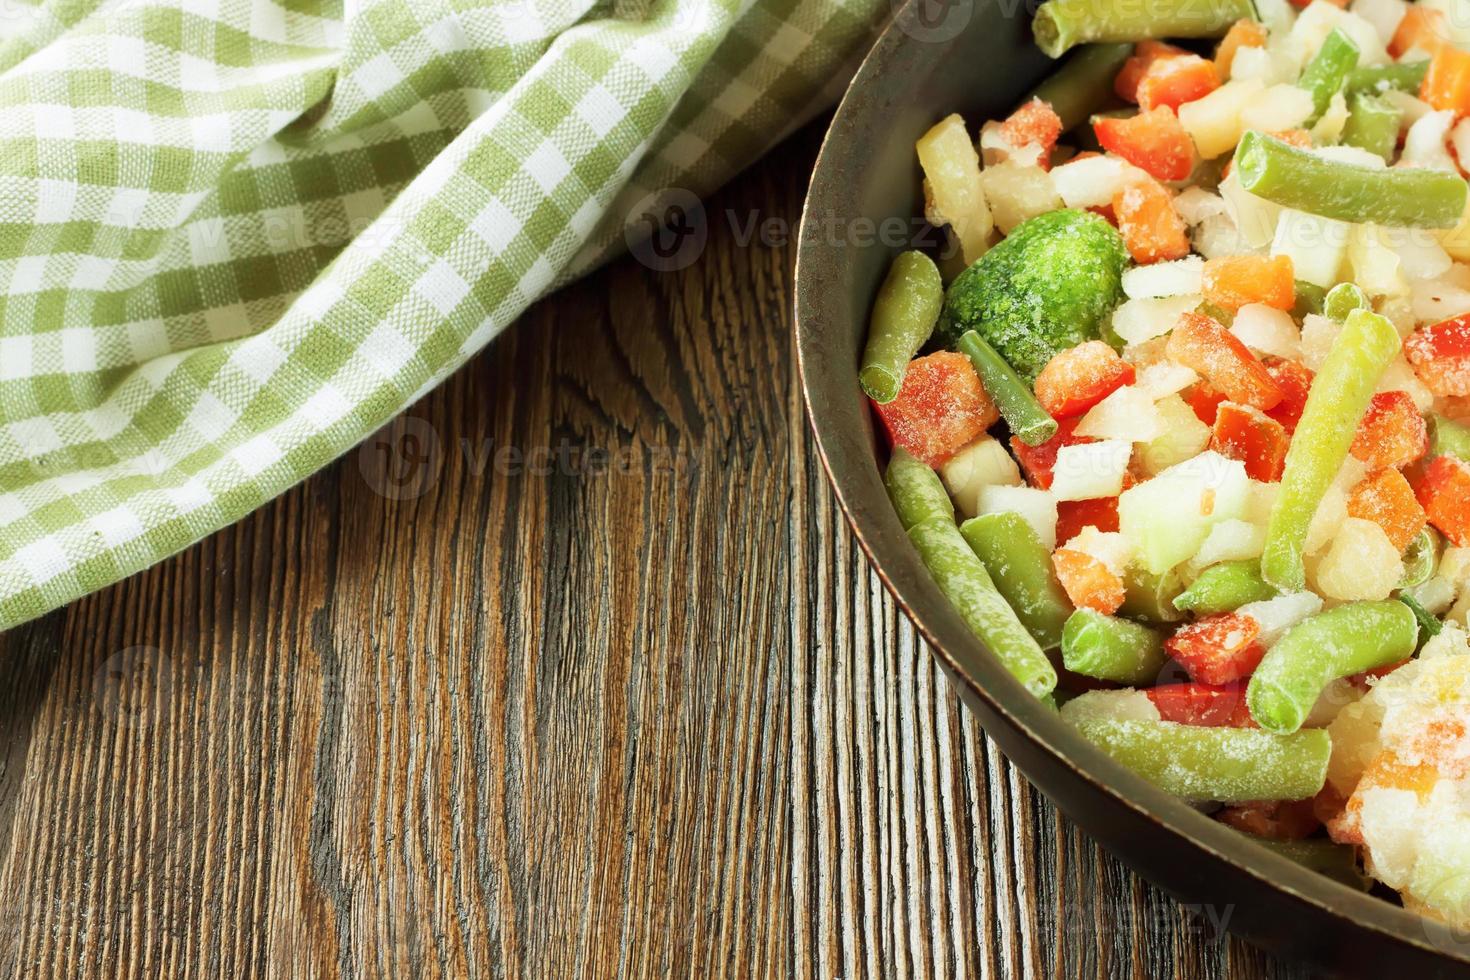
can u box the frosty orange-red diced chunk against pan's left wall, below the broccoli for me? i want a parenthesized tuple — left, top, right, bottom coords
(873, 351, 1001, 466)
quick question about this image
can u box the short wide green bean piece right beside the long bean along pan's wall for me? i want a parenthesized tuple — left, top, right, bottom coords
(960, 514, 1072, 649)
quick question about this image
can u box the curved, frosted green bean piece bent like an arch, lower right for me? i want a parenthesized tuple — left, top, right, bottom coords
(1245, 599, 1419, 735)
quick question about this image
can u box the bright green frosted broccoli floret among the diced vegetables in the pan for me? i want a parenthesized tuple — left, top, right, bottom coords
(936, 210, 1127, 379)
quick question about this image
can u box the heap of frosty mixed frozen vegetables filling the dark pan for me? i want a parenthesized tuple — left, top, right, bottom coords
(863, 0, 1470, 927)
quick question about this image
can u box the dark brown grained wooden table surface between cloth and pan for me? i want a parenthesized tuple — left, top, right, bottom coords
(0, 125, 1304, 979)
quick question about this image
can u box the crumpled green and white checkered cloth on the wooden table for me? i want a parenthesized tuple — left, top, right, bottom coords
(0, 0, 888, 627)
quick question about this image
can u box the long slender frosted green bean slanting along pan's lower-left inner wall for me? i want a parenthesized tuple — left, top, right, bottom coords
(908, 517, 1057, 698)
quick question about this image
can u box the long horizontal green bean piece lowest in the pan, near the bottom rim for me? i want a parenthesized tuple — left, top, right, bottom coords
(1078, 720, 1332, 804)
